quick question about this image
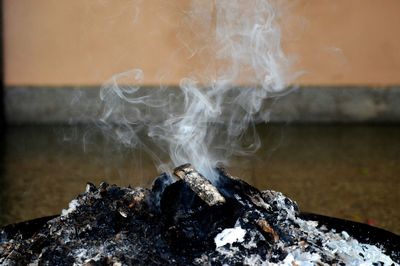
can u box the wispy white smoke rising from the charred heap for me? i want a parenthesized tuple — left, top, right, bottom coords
(100, 0, 294, 181)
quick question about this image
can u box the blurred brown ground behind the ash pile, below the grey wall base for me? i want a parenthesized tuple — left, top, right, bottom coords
(0, 124, 400, 234)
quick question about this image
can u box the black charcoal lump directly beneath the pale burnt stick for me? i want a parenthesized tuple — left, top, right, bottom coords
(161, 180, 241, 251)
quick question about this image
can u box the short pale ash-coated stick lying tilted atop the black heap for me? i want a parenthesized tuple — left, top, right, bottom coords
(174, 164, 225, 206)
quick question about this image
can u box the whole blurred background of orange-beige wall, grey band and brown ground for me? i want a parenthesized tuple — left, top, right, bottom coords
(0, 0, 400, 234)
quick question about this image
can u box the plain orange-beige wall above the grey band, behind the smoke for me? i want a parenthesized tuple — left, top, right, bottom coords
(3, 0, 400, 85)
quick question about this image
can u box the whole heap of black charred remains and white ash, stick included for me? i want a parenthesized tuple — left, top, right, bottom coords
(0, 165, 399, 265)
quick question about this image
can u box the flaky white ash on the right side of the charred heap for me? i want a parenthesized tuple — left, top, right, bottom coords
(216, 191, 399, 266)
